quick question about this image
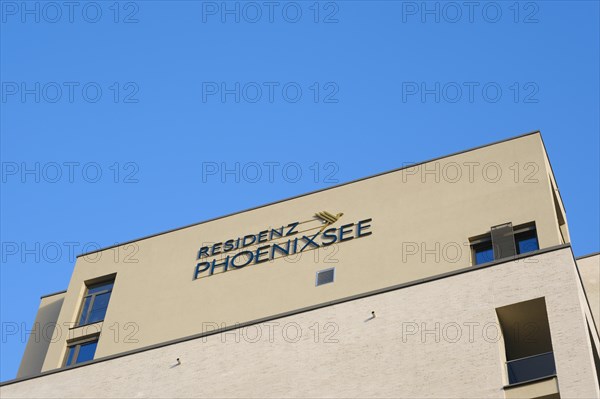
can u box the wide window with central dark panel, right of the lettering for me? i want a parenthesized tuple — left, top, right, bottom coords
(470, 222, 540, 265)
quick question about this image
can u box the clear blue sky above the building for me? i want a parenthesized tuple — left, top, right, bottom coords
(0, 1, 600, 381)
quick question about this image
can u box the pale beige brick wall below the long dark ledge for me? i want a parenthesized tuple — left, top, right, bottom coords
(0, 248, 600, 398)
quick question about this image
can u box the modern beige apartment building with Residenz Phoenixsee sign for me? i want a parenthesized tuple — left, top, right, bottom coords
(0, 132, 600, 399)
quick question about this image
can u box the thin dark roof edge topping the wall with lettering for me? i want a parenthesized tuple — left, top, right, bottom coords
(77, 130, 547, 258)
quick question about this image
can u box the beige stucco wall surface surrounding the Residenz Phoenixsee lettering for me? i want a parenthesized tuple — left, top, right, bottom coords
(35, 134, 562, 370)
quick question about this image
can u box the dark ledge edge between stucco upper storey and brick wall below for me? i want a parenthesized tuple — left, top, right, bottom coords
(0, 244, 574, 387)
